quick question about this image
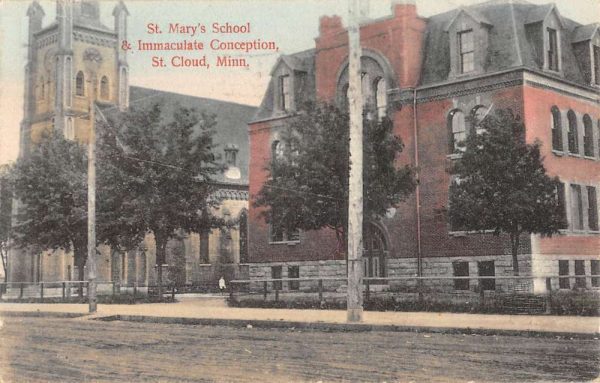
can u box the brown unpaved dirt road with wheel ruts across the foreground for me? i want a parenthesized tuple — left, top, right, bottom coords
(0, 317, 600, 383)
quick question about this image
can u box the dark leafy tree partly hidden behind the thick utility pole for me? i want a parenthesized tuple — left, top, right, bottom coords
(255, 103, 415, 253)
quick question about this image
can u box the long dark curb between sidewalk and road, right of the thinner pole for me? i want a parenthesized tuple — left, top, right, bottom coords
(90, 315, 600, 339)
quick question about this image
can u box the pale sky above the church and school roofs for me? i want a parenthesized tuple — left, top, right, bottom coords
(0, 0, 600, 164)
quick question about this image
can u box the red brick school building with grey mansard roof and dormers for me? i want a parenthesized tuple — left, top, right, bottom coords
(249, 1, 600, 292)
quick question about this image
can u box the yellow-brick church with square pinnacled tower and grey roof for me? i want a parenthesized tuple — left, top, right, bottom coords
(8, 0, 256, 288)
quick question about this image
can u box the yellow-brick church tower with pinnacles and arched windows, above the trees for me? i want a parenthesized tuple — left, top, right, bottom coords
(21, 0, 129, 156)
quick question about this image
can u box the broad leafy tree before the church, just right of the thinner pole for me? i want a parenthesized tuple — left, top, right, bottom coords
(99, 104, 224, 296)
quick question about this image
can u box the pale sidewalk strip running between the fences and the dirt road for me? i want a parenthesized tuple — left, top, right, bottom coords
(0, 297, 600, 337)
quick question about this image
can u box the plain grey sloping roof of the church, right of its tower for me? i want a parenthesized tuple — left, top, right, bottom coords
(129, 86, 256, 185)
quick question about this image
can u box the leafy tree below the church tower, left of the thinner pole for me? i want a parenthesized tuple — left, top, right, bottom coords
(12, 131, 87, 296)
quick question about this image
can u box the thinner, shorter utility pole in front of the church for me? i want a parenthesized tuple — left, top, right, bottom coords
(87, 74, 98, 313)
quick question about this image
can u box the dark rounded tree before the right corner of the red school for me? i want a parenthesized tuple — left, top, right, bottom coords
(448, 109, 566, 275)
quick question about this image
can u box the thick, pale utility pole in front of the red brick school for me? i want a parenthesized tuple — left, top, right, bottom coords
(347, 0, 363, 322)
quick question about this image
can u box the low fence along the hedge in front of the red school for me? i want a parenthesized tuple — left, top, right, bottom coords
(229, 275, 600, 311)
